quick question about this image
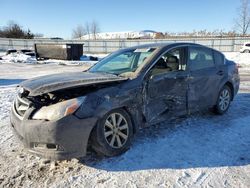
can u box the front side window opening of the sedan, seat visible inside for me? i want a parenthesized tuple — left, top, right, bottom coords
(152, 48, 186, 75)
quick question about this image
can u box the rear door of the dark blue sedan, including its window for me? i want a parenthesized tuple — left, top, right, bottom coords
(188, 46, 224, 111)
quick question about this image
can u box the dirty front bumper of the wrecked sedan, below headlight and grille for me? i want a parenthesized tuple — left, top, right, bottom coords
(10, 104, 97, 160)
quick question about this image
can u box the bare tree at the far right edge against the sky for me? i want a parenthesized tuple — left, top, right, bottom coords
(235, 0, 250, 36)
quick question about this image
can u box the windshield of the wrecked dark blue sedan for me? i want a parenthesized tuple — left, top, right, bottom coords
(89, 48, 155, 75)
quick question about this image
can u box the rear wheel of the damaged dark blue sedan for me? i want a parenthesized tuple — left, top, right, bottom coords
(215, 85, 232, 115)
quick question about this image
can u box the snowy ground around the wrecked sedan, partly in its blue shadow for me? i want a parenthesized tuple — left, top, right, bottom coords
(0, 54, 250, 187)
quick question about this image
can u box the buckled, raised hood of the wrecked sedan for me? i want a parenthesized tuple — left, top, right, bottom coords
(19, 72, 127, 96)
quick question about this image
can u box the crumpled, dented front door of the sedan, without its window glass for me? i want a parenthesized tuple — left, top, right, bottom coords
(144, 48, 189, 124)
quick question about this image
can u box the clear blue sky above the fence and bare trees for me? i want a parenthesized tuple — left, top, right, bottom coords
(0, 0, 240, 38)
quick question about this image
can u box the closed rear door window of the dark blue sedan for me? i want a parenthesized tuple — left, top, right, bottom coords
(188, 47, 214, 70)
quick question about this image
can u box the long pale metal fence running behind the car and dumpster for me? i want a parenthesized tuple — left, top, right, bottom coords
(0, 37, 250, 53)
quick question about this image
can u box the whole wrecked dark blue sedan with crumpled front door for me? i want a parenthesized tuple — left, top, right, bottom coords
(11, 43, 240, 160)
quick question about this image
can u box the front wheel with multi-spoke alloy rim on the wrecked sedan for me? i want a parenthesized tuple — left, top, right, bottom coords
(91, 109, 133, 157)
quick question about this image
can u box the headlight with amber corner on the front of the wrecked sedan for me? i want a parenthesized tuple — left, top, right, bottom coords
(32, 97, 85, 121)
